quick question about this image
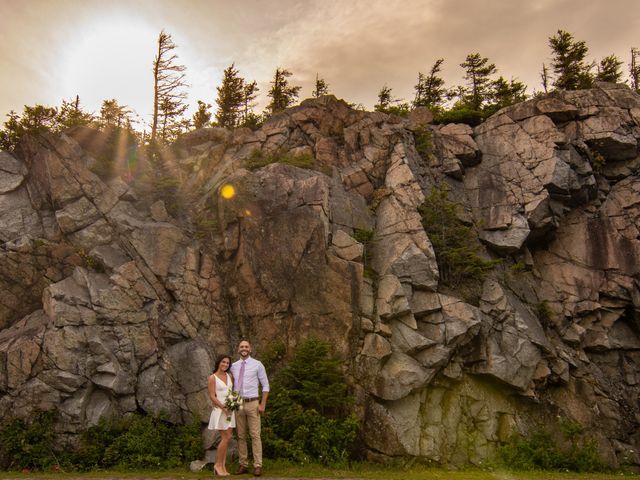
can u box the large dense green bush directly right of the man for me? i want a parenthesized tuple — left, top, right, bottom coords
(262, 338, 358, 465)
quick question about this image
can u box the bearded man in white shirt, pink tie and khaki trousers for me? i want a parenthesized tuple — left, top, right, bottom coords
(231, 340, 269, 477)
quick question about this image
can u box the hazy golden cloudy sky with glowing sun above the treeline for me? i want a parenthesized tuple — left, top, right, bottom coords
(0, 0, 640, 129)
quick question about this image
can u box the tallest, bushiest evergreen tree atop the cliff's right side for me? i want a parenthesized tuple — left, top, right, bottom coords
(549, 30, 593, 90)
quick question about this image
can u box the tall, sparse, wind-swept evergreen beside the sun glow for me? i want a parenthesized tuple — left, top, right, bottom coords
(151, 30, 187, 143)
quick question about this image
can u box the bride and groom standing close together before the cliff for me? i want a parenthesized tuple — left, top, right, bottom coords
(208, 340, 269, 477)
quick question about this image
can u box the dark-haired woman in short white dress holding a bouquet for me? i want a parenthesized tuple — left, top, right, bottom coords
(207, 355, 236, 477)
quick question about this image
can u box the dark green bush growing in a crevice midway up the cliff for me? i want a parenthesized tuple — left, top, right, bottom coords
(418, 184, 499, 287)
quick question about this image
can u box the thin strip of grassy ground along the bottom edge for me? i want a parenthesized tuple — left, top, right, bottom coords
(0, 462, 640, 480)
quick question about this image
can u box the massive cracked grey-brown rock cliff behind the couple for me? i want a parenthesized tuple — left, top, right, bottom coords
(0, 84, 640, 465)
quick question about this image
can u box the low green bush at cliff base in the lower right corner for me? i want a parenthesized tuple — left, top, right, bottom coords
(497, 421, 606, 472)
